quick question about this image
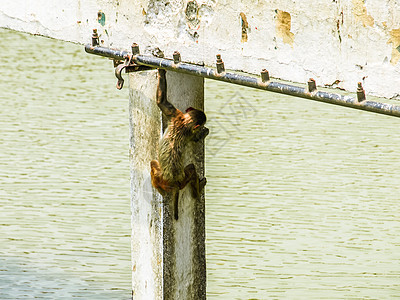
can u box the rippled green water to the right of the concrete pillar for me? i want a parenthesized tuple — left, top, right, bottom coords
(206, 78, 400, 299)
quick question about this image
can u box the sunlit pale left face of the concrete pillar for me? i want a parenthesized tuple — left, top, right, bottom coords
(129, 71, 163, 299)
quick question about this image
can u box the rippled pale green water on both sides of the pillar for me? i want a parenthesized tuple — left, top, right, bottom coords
(0, 30, 400, 300)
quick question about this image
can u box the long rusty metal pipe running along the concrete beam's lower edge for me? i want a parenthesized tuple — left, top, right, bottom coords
(85, 45, 400, 117)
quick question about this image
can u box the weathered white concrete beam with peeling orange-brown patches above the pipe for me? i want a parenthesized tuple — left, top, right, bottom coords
(0, 0, 400, 99)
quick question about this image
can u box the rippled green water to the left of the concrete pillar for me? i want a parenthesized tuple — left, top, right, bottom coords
(0, 30, 131, 299)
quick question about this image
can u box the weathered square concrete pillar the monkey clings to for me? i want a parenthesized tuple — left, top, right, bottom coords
(129, 71, 206, 300)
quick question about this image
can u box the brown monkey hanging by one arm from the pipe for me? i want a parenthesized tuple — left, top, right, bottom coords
(150, 69, 209, 220)
